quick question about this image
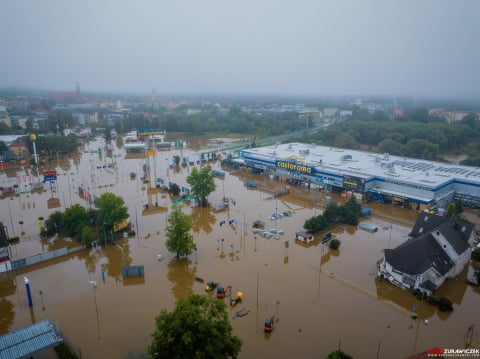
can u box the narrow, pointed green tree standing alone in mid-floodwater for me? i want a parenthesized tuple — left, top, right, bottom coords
(165, 205, 195, 258)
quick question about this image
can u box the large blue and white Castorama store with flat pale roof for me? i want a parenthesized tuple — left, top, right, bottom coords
(227, 143, 480, 210)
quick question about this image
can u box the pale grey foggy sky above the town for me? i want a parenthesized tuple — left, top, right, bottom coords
(0, 0, 480, 98)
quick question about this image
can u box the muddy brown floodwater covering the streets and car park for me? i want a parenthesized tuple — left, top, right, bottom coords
(0, 140, 480, 358)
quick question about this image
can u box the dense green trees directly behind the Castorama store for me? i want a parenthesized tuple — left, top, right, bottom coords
(303, 110, 480, 165)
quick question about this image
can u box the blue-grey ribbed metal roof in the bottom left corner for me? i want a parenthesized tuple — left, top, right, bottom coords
(0, 320, 63, 359)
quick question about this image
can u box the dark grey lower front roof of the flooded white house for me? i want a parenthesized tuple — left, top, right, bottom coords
(385, 234, 454, 275)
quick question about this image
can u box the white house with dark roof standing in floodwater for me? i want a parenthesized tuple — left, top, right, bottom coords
(377, 212, 475, 294)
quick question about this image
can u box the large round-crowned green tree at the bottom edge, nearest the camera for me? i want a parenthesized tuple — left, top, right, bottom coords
(148, 294, 242, 359)
